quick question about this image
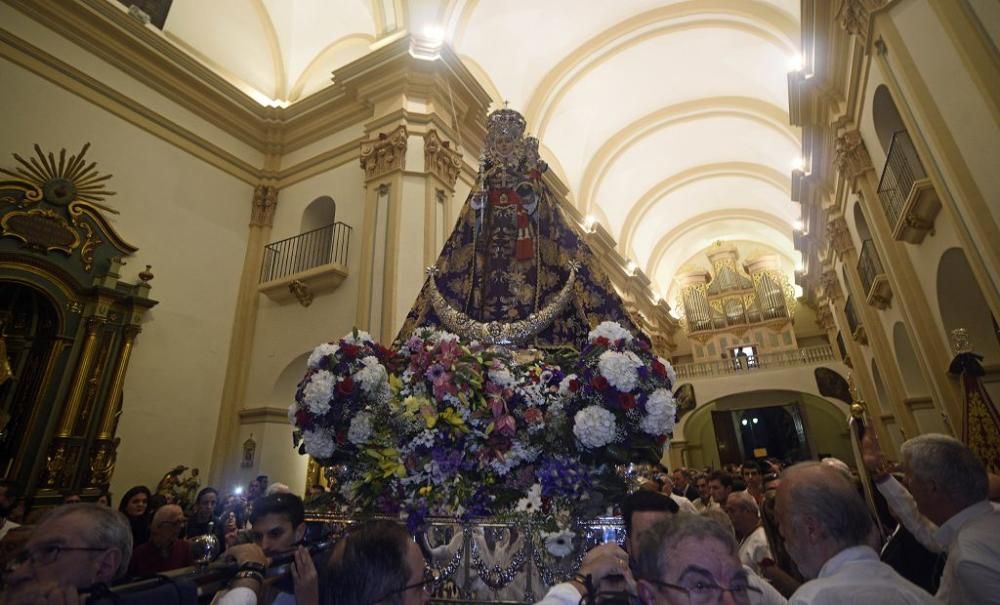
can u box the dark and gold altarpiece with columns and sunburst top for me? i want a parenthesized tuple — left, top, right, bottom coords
(0, 145, 156, 506)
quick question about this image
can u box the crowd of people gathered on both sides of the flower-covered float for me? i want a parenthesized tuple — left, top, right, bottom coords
(0, 435, 1000, 605)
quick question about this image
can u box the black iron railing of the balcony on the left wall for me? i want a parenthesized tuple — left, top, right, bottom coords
(260, 222, 351, 283)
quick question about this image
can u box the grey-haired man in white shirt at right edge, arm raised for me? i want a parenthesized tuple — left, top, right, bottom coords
(864, 431, 1000, 604)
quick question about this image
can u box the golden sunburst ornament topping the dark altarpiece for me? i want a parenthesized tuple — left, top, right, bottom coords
(0, 143, 118, 214)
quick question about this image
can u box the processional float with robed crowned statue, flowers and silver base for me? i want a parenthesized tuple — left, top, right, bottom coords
(289, 108, 676, 602)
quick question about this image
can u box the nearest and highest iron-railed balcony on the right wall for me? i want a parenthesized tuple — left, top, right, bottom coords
(878, 130, 941, 244)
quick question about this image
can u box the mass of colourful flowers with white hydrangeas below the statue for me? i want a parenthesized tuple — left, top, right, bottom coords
(289, 322, 676, 556)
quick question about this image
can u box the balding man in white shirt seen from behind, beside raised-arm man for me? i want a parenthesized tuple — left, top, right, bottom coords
(775, 462, 934, 605)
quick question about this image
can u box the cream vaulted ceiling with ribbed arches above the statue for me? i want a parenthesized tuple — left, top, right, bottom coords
(164, 0, 801, 310)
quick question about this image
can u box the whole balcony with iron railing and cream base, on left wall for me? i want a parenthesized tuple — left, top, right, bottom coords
(257, 222, 351, 307)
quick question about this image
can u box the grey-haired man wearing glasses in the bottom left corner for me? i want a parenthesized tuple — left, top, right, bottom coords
(4, 503, 132, 605)
